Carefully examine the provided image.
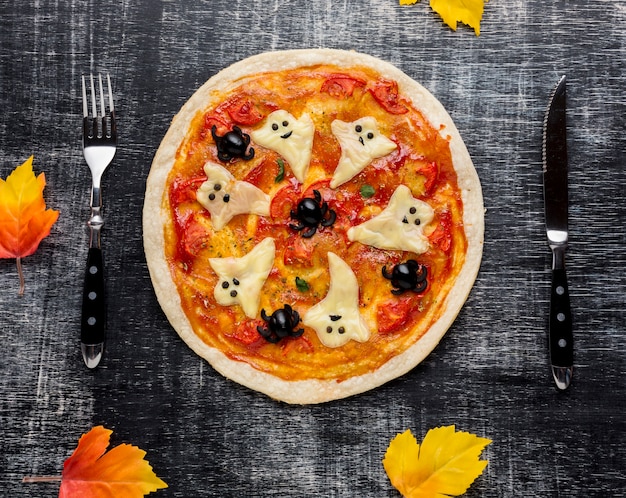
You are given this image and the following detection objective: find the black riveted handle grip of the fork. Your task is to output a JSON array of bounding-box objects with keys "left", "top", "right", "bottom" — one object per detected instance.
[{"left": 80, "top": 247, "right": 106, "bottom": 344}]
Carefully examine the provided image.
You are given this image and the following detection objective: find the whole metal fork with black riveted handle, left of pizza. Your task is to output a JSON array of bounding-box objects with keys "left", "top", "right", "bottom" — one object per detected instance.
[{"left": 80, "top": 74, "right": 117, "bottom": 368}]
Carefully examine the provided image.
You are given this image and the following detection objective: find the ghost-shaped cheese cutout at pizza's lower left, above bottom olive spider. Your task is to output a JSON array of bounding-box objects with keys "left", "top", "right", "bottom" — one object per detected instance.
[{"left": 209, "top": 237, "right": 276, "bottom": 318}]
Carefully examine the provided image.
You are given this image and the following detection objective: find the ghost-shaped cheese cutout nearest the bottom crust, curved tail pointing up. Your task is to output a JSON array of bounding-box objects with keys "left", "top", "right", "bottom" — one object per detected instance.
[{"left": 302, "top": 252, "right": 370, "bottom": 348}]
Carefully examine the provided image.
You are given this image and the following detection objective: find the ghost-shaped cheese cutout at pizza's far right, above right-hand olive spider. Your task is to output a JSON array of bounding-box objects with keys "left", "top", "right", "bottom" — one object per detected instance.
[{"left": 348, "top": 185, "right": 434, "bottom": 254}]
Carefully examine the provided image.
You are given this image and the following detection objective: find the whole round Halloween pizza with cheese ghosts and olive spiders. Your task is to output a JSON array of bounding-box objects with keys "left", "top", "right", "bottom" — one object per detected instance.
[{"left": 143, "top": 49, "right": 483, "bottom": 404}]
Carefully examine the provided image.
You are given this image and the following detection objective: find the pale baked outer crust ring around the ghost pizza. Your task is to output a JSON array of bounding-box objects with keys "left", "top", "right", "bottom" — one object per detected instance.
[{"left": 143, "top": 49, "right": 484, "bottom": 404}]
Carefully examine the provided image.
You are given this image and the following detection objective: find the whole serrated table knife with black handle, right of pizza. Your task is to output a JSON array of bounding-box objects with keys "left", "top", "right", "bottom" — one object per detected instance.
[{"left": 543, "top": 76, "right": 574, "bottom": 390}]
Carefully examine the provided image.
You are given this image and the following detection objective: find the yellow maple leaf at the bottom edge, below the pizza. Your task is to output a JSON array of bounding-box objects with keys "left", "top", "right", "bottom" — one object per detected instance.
[{"left": 383, "top": 425, "right": 491, "bottom": 498}]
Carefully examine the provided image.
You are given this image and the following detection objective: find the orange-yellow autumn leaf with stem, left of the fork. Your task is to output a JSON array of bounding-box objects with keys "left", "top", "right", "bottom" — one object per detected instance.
[{"left": 0, "top": 156, "right": 59, "bottom": 294}]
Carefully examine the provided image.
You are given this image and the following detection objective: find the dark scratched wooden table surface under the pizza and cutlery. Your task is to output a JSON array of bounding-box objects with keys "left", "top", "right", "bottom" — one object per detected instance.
[{"left": 0, "top": 0, "right": 626, "bottom": 498}]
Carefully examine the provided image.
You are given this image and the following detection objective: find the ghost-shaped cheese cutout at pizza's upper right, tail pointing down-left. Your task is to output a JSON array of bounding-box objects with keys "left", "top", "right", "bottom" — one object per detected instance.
[{"left": 330, "top": 116, "right": 397, "bottom": 188}]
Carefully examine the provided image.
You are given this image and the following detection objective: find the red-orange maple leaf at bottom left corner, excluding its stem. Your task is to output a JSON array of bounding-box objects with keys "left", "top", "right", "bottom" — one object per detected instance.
[{"left": 59, "top": 426, "right": 167, "bottom": 498}]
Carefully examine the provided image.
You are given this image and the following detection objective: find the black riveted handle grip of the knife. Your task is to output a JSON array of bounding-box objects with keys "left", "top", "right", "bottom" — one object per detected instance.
[{"left": 549, "top": 268, "right": 574, "bottom": 367}]
